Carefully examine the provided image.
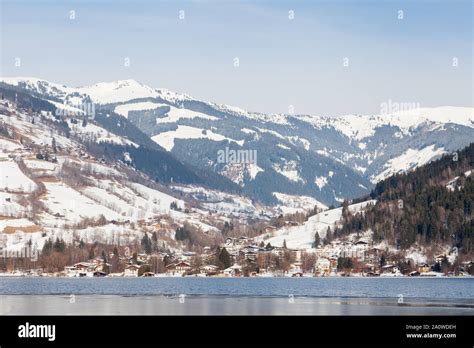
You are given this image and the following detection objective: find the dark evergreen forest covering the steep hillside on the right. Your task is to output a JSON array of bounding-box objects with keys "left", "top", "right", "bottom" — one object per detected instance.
[{"left": 333, "top": 143, "right": 474, "bottom": 254}]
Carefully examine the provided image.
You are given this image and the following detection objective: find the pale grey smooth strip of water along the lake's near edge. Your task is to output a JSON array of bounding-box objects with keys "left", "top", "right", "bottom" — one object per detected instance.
[{"left": 0, "top": 295, "right": 474, "bottom": 315}]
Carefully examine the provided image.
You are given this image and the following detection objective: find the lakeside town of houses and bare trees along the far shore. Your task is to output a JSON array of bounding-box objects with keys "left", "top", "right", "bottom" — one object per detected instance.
[{"left": 0, "top": 235, "right": 474, "bottom": 277}]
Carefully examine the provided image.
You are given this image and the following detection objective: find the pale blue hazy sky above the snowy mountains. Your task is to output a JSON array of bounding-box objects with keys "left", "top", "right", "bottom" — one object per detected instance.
[{"left": 0, "top": 0, "right": 474, "bottom": 116}]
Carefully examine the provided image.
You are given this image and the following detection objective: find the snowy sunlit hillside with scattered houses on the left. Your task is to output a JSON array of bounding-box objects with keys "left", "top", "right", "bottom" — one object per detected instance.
[{"left": 0, "top": 100, "right": 278, "bottom": 251}]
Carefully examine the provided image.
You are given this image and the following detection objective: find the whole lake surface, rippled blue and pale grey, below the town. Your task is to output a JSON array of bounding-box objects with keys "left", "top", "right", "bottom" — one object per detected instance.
[{"left": 0, "top": 277, "right": 474, "bottom": 315}]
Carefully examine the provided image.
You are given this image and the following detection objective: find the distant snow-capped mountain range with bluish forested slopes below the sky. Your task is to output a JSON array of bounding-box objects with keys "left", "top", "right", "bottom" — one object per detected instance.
[{"left": 1, "top": 78, "right": 474, "bottom": 205}]
